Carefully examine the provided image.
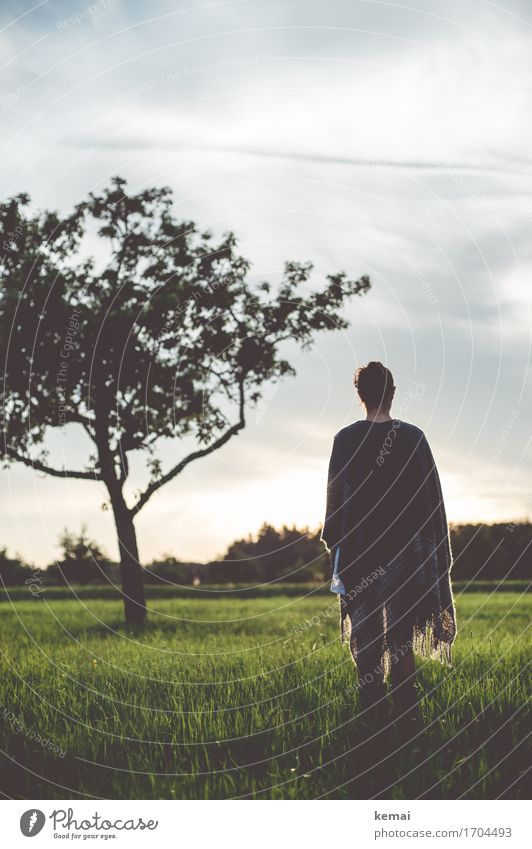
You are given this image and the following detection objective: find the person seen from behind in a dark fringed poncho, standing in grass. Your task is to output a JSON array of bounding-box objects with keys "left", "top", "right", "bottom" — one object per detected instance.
[{"left": 321, "top": 362, "right": 456, "bottom": 723}]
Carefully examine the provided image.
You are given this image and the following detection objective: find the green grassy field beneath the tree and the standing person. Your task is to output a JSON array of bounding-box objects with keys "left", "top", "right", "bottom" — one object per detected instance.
[{"left": 0, "top": 586, "right": 532, "bottom": 799}]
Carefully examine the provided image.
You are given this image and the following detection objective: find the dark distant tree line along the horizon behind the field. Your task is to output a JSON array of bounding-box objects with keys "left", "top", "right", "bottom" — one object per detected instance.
[{"left": 0, "top": 522, "right": 532, "bottom": 586}]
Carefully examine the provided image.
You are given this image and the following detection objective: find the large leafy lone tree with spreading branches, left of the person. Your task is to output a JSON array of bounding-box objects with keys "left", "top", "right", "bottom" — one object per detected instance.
[{"left": 0, "top": 177, "right": 370, "bottom": 624}]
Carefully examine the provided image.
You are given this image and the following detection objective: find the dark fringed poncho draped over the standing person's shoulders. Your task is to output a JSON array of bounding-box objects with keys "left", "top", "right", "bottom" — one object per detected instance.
[{"left": 322, "top": 419, "right": 456, "bottom": 674}]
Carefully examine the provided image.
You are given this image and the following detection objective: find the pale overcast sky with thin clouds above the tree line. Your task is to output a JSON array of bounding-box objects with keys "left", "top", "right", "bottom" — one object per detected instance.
[{"left": 0, "top": 0, "right": 532, "bottom": 565}]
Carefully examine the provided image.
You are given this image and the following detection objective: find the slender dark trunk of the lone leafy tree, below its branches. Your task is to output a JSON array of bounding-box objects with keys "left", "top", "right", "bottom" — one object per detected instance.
[{"left": 113, "top": 498, "right": 146, "bottom": 625}]
